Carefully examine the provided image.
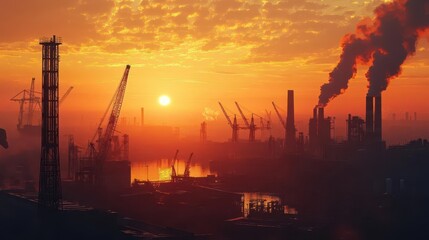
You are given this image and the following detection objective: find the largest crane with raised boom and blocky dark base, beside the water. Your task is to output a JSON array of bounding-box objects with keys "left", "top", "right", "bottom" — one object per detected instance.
[{"left": 73, "top": 65, "right": 131, "bottom": 190}]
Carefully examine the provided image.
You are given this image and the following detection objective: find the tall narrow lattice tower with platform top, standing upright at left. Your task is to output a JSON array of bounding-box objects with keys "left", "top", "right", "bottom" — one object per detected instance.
[{"left": 38, "top": 35, "right": 62, "bottom": 210}]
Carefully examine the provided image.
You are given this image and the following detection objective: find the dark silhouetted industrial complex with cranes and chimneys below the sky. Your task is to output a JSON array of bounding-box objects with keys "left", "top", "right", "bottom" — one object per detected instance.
[{"left": 0, "top": 31, "right": 429, "bottom": 239}]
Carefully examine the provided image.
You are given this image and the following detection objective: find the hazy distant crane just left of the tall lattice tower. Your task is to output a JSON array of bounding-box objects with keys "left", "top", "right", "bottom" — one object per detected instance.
[{"left": 10, "top": 78, "right": 41, "bottom": 135}]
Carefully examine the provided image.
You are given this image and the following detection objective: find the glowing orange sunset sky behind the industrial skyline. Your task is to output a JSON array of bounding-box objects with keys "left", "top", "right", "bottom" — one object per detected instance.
[{"left": 0, "top": 0, "right": 429, "bottom": 142}]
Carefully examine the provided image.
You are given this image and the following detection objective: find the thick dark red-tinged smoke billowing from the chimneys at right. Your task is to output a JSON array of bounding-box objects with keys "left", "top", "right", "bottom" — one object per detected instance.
[{"left": 319, "top": 0, "right": 429, "bottom": 106}]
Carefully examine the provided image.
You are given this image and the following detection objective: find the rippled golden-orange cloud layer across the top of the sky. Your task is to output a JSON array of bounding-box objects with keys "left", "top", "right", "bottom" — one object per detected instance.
[{"left": 0, "top": 0, "right": 392, "bottom": 62}]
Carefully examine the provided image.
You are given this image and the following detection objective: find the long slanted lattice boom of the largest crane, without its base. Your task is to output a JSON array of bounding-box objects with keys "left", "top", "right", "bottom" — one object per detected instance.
[{"left": 95, "top": 65, "right": 130, "bottom": 182}]
